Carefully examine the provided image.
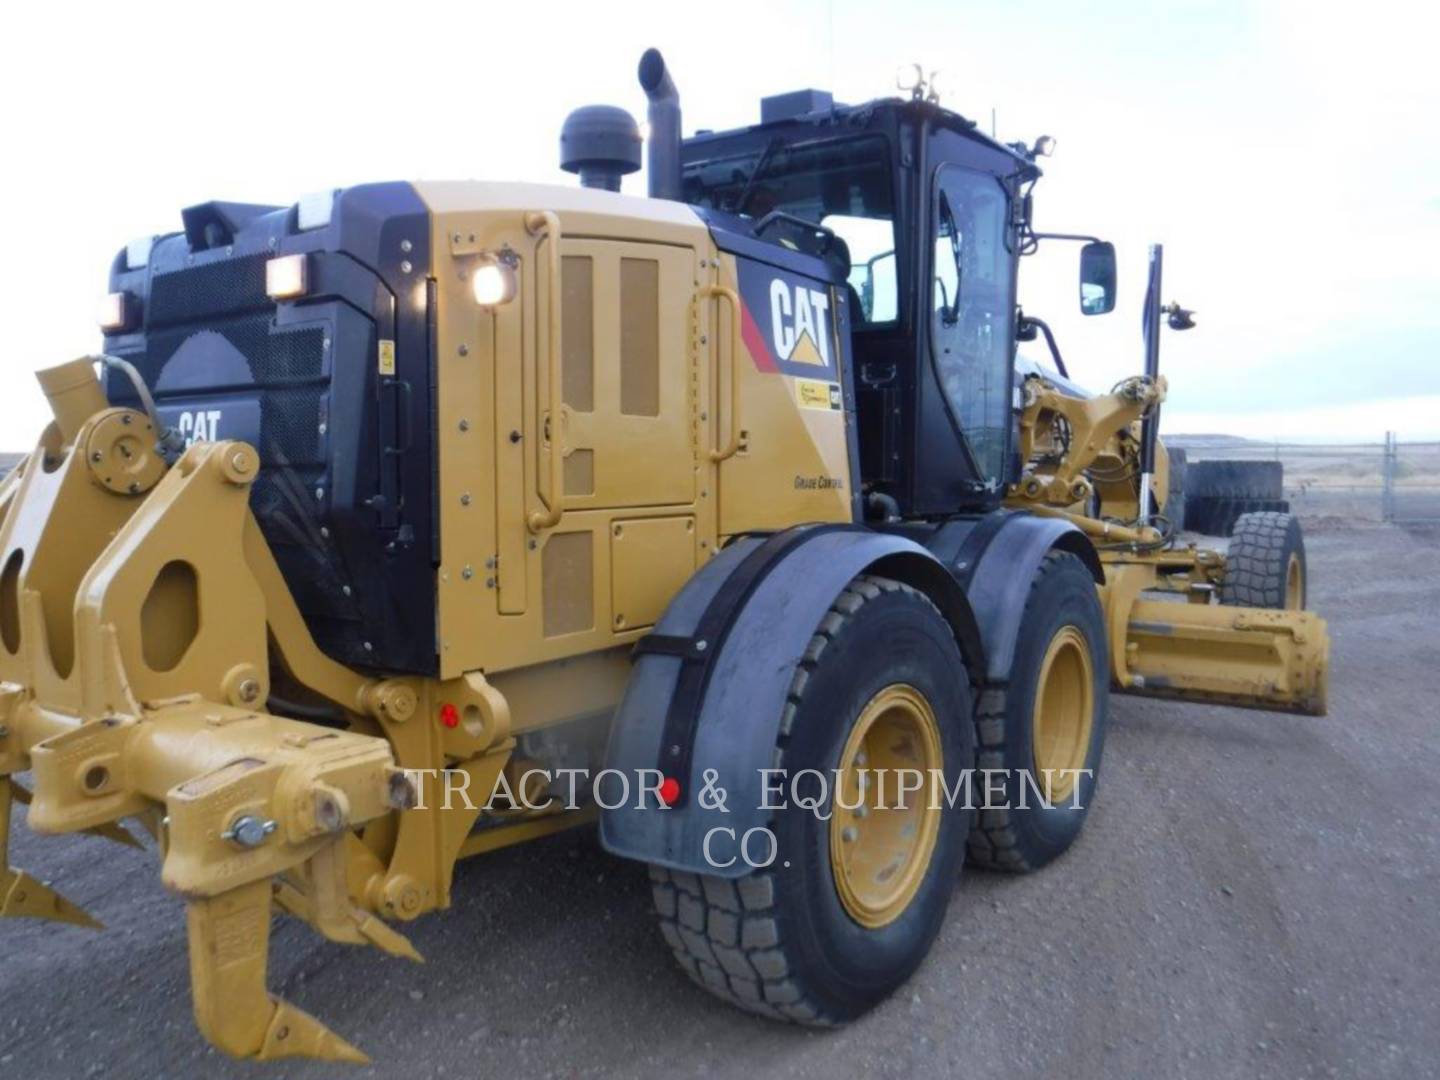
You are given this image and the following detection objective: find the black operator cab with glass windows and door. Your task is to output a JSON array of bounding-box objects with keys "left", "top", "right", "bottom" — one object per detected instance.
[{"left": 680, "top": 89, "right": 1113, "bottom": 518}]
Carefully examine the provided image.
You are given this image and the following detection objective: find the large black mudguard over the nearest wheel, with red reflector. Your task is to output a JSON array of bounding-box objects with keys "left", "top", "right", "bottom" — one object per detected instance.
[{"left": 600, "top": 526, "right": 984, "bottom": 877}]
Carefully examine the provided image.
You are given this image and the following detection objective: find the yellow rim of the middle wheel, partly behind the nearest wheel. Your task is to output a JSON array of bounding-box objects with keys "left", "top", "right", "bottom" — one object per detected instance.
[{"left": 1031, "top": 626, "right": 1094, "bottom": 802}]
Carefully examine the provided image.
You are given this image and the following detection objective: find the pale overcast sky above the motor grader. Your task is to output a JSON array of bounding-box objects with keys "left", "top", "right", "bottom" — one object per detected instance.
[{"left": 0, "top": 0, "right": 1440, "bottom": 449}]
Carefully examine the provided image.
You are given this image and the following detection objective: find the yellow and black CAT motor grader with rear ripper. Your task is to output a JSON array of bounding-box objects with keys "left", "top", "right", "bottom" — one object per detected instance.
[{"left": 0, "top": 50, "right": 1328, "bottom": 1061}]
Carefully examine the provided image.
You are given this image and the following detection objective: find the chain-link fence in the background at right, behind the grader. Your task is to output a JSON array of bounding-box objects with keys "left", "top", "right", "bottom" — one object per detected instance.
[{"left": 1165, "top": 433, "right": 1440, "bottom": 524}]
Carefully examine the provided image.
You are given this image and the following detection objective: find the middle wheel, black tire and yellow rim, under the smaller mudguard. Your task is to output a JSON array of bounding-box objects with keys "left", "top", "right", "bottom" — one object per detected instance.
[{"left": 969, "top": 552, "right": 1110, "bottom": 873}]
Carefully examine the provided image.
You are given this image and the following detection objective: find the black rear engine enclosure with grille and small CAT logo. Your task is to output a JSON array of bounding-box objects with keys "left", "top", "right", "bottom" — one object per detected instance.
[{"left": 105, "top": 183, "right": 438, "bottom": 674}]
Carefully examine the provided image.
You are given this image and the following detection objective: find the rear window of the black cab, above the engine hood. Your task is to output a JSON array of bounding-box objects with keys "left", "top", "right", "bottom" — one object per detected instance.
[{"left": 684, "top": 135, "right": 897, "bottom": 327}]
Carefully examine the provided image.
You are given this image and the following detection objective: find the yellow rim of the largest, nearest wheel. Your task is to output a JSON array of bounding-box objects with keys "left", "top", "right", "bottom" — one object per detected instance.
[{"left": 829, "top": 683, "right": 945, "bottom": 929}]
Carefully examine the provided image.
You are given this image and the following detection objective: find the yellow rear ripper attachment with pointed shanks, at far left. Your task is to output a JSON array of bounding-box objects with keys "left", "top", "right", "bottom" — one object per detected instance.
[{"left": 0, "top": 360, "right": 419, "bottom": 1061}]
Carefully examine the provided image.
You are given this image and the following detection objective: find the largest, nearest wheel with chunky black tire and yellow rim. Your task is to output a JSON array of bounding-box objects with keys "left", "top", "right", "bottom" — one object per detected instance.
[{"left": 651, "top": 576, "right": 973, "bottom": 1025}]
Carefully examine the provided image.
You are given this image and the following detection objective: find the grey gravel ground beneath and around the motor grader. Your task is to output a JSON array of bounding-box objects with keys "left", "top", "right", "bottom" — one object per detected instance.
[{"left": 0, "top": 526, "right": 1440, "bottom": 1080}]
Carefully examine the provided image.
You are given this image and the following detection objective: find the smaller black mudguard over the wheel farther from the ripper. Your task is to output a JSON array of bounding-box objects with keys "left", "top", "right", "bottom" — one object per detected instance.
[{"left": 926, "top": 510, "right": 1104, "bottom": 684}]
